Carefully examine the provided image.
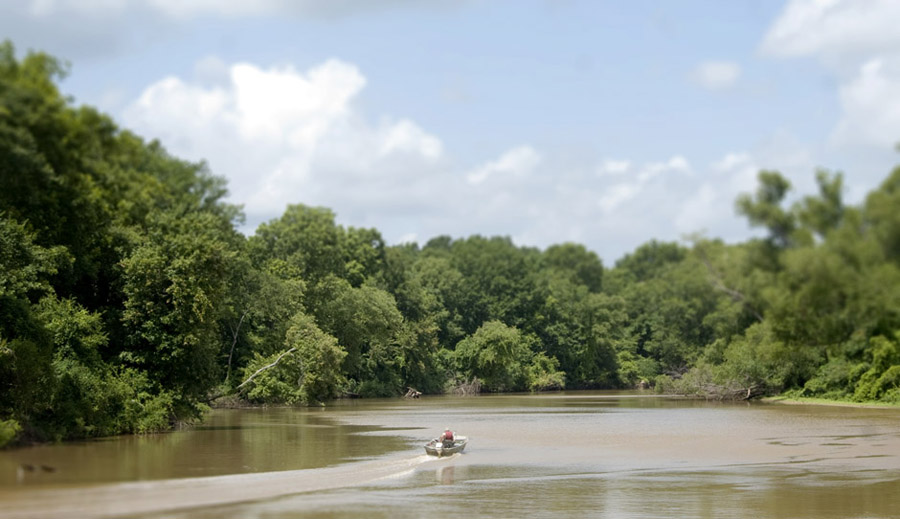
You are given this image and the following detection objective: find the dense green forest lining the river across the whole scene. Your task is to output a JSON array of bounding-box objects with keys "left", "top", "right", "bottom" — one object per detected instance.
[{"left": 0, "top": 42, "right": 900, "bottom": 446}]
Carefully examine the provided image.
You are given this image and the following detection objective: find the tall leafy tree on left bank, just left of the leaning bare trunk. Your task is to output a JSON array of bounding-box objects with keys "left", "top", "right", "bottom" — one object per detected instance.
[{"left": 121, "top": 212, "right": 239, "bottom": 416}]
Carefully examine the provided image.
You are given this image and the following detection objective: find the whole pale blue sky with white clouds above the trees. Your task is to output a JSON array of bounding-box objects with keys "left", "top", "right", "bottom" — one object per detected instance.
[{"left": 0, "top": 0, "right": 900, "bottom": 260}]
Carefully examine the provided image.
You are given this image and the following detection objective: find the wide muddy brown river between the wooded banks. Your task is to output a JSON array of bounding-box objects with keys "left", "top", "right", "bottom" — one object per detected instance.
[{"left": 0, "top": 392, "right": 900, "bottom": 519}]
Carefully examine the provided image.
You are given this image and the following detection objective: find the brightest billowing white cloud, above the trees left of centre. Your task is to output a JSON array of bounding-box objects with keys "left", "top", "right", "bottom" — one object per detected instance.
[{"left": 124, "top": 60, "right": 443, "bottom": 225}]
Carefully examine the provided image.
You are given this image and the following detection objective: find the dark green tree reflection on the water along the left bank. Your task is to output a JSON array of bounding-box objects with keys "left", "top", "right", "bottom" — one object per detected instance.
[{"left": 0, "top": 408, "right": 406, "bottom": 488}]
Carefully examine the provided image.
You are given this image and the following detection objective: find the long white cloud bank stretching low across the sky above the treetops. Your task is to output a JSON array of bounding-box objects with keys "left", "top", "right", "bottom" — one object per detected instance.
[{"left": 123, "top": 54, "right": 811, "bottom": 261}]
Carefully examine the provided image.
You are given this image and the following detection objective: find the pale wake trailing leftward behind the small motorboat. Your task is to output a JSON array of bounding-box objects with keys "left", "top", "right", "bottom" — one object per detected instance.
[{"left": 0, "top": 454, "right": 436, "bottom": 519}]
